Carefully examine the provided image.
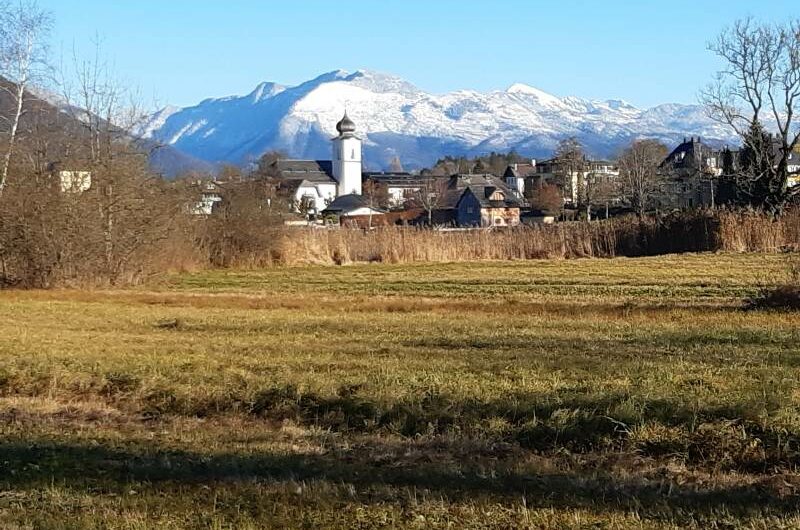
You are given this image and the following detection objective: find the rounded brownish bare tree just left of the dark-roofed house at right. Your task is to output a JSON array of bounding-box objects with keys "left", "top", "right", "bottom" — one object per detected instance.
[{"left": 619, "top": 140, "right": 669, "bottom": 218}]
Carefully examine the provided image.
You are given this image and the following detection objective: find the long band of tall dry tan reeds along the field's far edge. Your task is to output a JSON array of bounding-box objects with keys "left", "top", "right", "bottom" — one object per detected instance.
[{"left": 242, "top": 211, "right": 800, "bottom": 266}]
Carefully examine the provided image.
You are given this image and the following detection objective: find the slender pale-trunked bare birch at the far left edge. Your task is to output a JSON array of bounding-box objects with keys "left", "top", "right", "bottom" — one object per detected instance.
[{"left": 0, "top": 0, "right": 52, "bottom": 194}]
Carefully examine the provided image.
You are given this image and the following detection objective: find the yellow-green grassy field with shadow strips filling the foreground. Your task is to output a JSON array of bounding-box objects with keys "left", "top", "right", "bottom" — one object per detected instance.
[{"left": 0, "top": 254, "right": 800, "bottom": 529}]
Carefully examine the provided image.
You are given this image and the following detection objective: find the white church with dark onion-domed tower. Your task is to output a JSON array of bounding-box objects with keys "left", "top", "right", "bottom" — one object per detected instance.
[{"left": 275, "top": 111, "right": 383, "bottom": 216}]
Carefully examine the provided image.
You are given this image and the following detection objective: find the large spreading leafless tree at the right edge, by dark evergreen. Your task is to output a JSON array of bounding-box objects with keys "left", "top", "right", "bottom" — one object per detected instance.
[{"left": 701, "top": 19, "right": 800, "bottom": 215}]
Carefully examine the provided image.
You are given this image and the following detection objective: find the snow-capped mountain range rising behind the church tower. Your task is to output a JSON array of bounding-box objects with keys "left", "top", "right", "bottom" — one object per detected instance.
[{"left": 137, "top": 70, "right": 735, "bottom": 169}]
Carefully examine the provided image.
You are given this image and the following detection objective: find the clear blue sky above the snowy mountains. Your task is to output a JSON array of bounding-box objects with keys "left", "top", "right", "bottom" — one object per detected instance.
[{"left": 40, "top": 0, "right": 800, "bottom": 106}]
